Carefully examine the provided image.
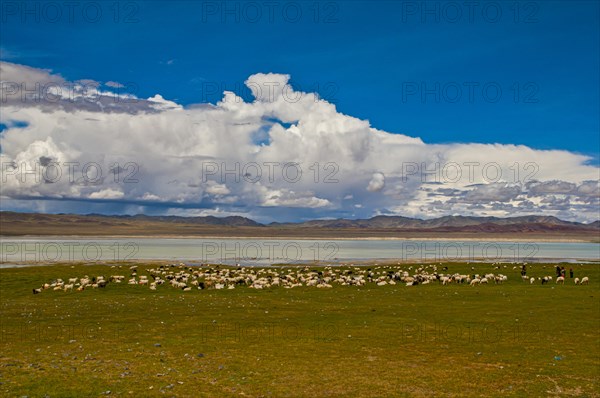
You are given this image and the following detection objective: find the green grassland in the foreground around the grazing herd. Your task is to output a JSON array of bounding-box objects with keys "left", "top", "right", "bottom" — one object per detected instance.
[{"left": 0, "top": 264, "right": 600, "bottom": 397}]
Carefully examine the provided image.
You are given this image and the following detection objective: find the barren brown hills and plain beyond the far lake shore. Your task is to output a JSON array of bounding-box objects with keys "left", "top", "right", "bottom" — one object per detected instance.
[{"left": 0, "top": 212, "right": 600, "bottom": 242}]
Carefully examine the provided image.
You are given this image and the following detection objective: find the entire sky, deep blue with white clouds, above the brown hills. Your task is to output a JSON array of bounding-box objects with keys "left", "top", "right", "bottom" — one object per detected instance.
[{"left": 0, "top": 0, "right": 600, "bottom": 222}]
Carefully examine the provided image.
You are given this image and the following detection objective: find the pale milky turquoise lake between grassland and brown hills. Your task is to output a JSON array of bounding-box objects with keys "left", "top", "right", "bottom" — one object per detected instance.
[{"left": 0, "top": 237, "right": 600, "bottom": 268}]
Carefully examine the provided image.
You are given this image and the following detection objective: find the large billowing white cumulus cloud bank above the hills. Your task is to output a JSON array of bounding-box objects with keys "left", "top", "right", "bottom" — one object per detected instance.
[{"left": 0, "top": 62, "right": 600, "bottom": 221}]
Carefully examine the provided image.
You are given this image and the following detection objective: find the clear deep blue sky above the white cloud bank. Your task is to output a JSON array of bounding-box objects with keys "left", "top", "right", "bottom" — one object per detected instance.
[{"left": 1, "top": 1, "right": 600, "bottom": 161}]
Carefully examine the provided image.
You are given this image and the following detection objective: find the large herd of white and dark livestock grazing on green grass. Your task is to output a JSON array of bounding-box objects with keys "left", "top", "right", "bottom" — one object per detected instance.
[{"left": 33, "top": 263, "right": 589, "bottom": 294}]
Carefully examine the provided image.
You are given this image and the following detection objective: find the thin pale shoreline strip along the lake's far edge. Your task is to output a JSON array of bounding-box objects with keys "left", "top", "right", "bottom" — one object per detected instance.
[{"left": 0, "top": 235, "right": 600, "bottom": 244}]
